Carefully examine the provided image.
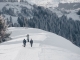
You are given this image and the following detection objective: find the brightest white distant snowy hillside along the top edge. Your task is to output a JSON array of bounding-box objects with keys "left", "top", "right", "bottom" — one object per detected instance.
[{"left": 26, "top": 0, "right": 80, "bottom": 7}]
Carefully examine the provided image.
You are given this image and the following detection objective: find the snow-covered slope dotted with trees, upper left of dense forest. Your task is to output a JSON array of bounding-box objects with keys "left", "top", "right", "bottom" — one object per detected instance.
[{"left": 0, "top": 2, "right": 32, "bottom": 24}]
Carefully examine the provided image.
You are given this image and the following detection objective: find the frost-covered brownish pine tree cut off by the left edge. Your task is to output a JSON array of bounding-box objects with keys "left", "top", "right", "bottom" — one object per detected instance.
[{"left": 0, "top": 16, "right": 11, "bottom": 42}]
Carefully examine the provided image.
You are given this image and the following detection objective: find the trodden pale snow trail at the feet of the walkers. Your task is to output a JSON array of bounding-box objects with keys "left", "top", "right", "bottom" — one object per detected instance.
[{"left": 14, "top": 43, "right": 41, "bottom": 60}]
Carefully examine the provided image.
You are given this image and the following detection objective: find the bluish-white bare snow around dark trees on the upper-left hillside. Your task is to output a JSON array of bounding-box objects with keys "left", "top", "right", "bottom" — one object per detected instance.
[{"left": 0, "top": 2, "right": 32, "bottom": 24}]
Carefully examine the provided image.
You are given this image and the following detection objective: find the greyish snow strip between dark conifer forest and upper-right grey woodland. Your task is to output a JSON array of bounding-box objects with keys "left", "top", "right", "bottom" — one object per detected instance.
[{"left": 49, "top": 8, "right": 80, "bottom": 21}]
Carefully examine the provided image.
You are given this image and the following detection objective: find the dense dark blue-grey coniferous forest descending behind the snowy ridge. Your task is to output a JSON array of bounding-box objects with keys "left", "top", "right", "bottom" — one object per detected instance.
[{"left": 18, "top": 5, "right": 80, "bottom": 47}]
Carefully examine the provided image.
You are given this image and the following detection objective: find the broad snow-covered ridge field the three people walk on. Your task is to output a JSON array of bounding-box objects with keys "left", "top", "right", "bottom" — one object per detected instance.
[{"left": 0, "top": 27, "right": 80, "bottom": 60}]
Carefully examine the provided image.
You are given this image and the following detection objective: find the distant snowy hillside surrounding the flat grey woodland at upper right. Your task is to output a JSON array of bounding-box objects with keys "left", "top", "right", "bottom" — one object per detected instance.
[{"left": 26, "top": 0, "right": 80, "bottom": 21}]
